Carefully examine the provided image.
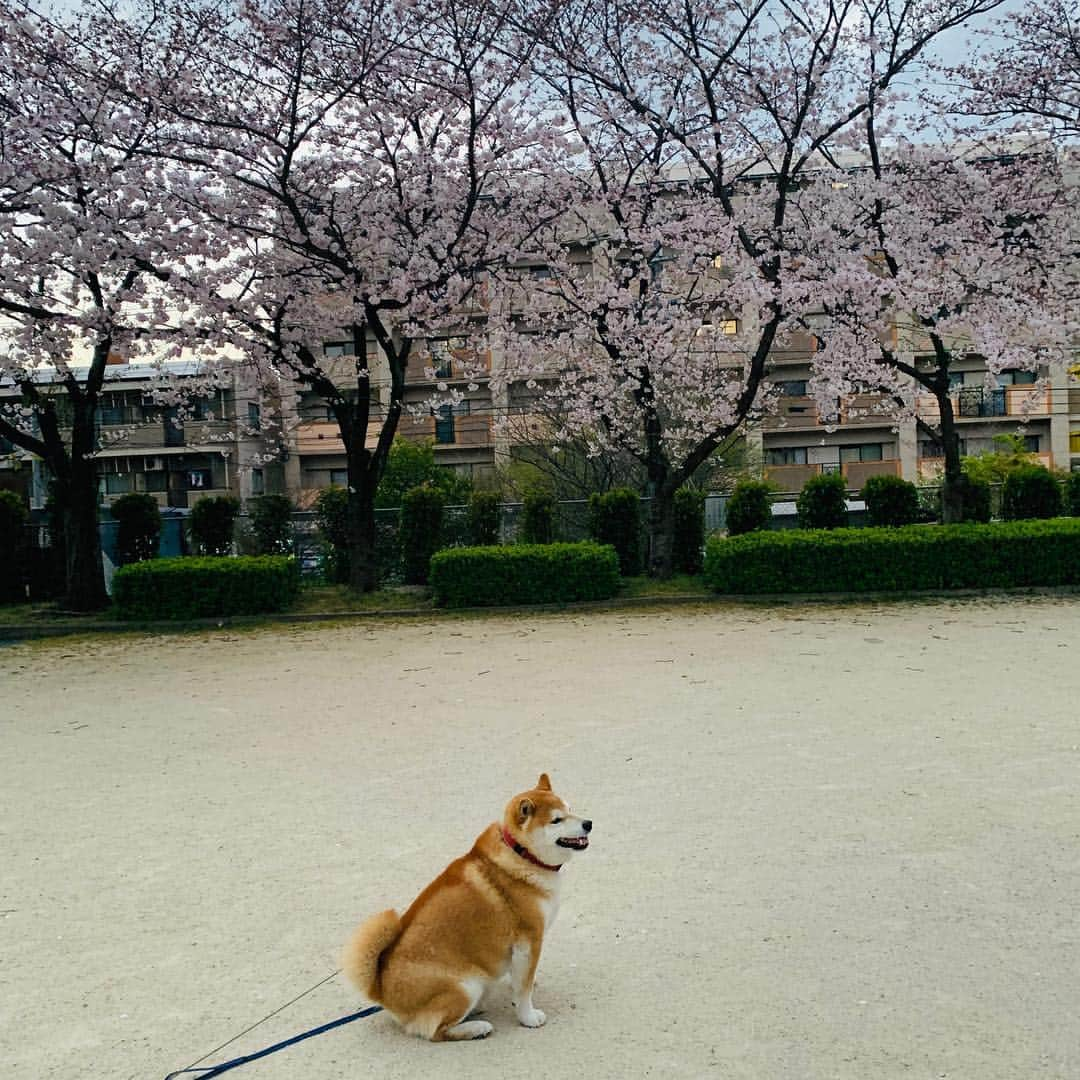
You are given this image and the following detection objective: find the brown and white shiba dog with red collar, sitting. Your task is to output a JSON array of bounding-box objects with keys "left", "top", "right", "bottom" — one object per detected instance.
[{"left": 342, "top": 773, "right": 593, "bottom": 1042}]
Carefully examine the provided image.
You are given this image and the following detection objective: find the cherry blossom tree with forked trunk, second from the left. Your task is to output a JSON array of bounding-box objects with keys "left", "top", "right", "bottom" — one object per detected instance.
[{"left": 133, "top": 0, "right": 546, "bottom": 590}]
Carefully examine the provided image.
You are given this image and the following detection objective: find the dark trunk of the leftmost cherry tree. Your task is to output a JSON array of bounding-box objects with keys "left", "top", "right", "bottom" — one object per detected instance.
[{"left": 54, "top": 400, "right": 109, "bottom": 611}]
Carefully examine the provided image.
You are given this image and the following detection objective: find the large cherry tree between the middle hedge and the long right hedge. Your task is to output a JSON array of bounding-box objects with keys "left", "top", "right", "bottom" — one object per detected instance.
[{"left": 496, "top": 0, "right": 1000, "bottom": 576}]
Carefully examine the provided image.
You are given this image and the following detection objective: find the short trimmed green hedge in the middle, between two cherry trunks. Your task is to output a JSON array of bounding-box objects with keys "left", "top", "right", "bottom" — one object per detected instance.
[{"left": 429, "top": 543, "right": 619, "bottom": 607}]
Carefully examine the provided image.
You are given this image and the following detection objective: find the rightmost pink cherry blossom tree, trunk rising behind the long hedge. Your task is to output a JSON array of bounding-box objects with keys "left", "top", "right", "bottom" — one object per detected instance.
[{"left": 811, "top": 141, "right": 1080, "bottom": 522}]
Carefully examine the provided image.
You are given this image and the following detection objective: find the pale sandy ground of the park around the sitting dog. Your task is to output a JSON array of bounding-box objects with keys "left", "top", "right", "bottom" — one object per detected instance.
[{"left": 0, "top": 599, "right": 1080, "bottom": 1080}]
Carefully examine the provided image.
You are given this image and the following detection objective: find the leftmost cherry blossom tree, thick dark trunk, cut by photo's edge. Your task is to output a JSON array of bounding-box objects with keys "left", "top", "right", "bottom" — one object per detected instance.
[{"left": 0, "top": 0, "right": 220, "bottom": 610}]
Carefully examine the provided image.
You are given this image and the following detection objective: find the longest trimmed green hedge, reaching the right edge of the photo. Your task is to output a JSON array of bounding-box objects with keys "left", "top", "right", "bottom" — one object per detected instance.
[{"left": 704, "top": 517, "right": 1080, "bottom": 594}]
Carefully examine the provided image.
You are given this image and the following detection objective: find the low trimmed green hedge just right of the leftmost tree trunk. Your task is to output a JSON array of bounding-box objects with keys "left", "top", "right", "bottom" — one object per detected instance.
[{"left": 112, "top": 555, "right": 300, "bottom": 619}]
